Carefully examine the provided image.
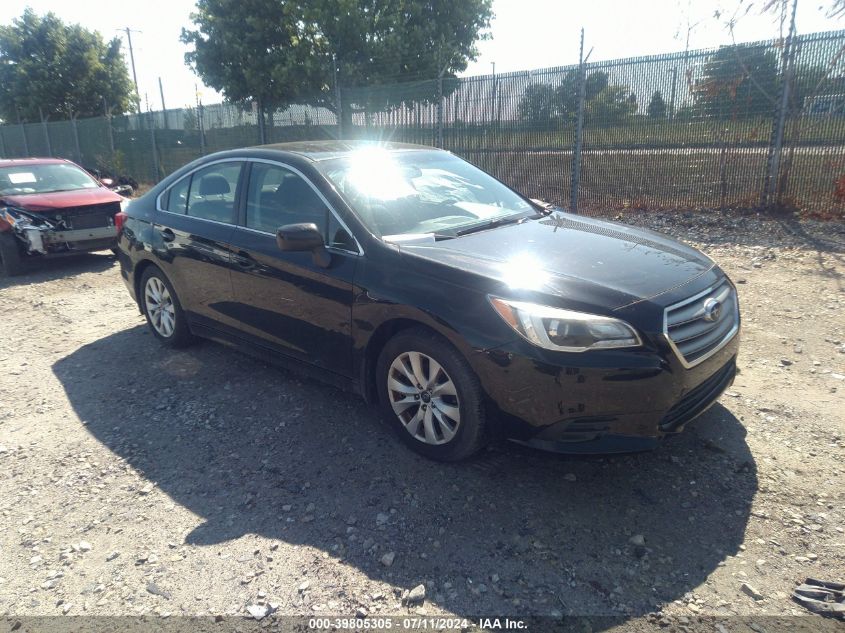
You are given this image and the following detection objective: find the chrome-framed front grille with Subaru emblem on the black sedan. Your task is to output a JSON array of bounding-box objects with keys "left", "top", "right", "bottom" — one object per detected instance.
[{"left": 663, "top": 279, "right": 739, "bottom": 367}]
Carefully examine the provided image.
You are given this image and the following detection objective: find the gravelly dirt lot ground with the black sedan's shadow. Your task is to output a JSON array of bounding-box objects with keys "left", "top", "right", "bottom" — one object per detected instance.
[{"left": 0, "top": 215, "right": 845, "bottom": 631}]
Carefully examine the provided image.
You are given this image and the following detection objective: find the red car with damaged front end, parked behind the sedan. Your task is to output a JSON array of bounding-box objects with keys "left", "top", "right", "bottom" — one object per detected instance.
[{"left": 0, "top": 158, "right": 127, "bottom": 275}]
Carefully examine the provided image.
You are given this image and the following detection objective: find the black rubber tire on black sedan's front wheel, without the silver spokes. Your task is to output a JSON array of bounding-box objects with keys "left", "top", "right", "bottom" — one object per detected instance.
[{"left": 375, "top": 328, "right": 490, "bottom": 462}]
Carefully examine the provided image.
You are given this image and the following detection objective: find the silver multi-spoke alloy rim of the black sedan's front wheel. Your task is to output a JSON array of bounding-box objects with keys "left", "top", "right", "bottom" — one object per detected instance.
[{"left": 387, "top": 352, "right": 461, "bottom": 445}]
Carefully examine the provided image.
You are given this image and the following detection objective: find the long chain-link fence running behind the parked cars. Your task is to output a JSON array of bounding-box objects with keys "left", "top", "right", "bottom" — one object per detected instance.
[{"left": 0, "top": 31, "right": 845, "bottom": 215}]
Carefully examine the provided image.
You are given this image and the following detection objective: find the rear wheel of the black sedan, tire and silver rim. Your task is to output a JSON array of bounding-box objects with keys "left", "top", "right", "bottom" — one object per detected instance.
[{"left": 139, "top": 266, "right": 196, "bottom": 348}]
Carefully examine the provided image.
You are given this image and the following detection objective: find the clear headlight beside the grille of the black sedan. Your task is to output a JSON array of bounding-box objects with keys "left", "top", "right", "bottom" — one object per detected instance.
[{"left": 489, "top": 297, "right": 642, "bottom": 352}]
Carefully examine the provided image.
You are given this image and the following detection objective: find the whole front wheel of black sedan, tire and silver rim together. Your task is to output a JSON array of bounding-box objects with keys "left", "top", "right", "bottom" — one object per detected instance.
[{"left": 376, "top": 329, "right": 490, "bottom": 462}]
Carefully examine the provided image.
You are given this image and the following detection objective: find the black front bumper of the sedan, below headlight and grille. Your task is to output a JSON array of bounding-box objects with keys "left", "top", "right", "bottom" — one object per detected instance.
[{"left": 471, "top": 333, "right": 739, "bottom": 453}]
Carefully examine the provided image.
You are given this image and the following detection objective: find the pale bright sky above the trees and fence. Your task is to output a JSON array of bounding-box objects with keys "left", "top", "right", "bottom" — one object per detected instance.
[{"left": 0, "top": 0, "right": 845, "bottom": 110}]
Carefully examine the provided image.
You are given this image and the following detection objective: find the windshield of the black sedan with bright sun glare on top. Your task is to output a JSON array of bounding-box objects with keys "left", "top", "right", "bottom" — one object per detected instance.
[{"left": 320, "top": 148, "right": 534, "bottom": 241}]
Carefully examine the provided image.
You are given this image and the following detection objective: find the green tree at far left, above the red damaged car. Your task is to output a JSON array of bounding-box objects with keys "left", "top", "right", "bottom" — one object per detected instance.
[{"left": 0, "top": 9, "right": 133, "bottom": 122}]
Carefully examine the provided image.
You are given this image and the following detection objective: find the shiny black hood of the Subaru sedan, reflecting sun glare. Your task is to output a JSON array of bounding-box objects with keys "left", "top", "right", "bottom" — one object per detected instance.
[{"left": 400, "top": 213, "right": 718, "bottom": 309}]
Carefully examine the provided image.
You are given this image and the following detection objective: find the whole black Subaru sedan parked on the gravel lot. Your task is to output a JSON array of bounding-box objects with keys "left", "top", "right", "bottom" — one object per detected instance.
[{"left": 113, "top": 141, "right": 740, "bottom": 460}]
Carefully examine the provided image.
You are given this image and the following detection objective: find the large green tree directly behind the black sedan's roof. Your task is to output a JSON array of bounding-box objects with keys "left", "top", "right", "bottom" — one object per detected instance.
[{"left": 182, "top": 0, "right": 492, "bottom": 122}]
